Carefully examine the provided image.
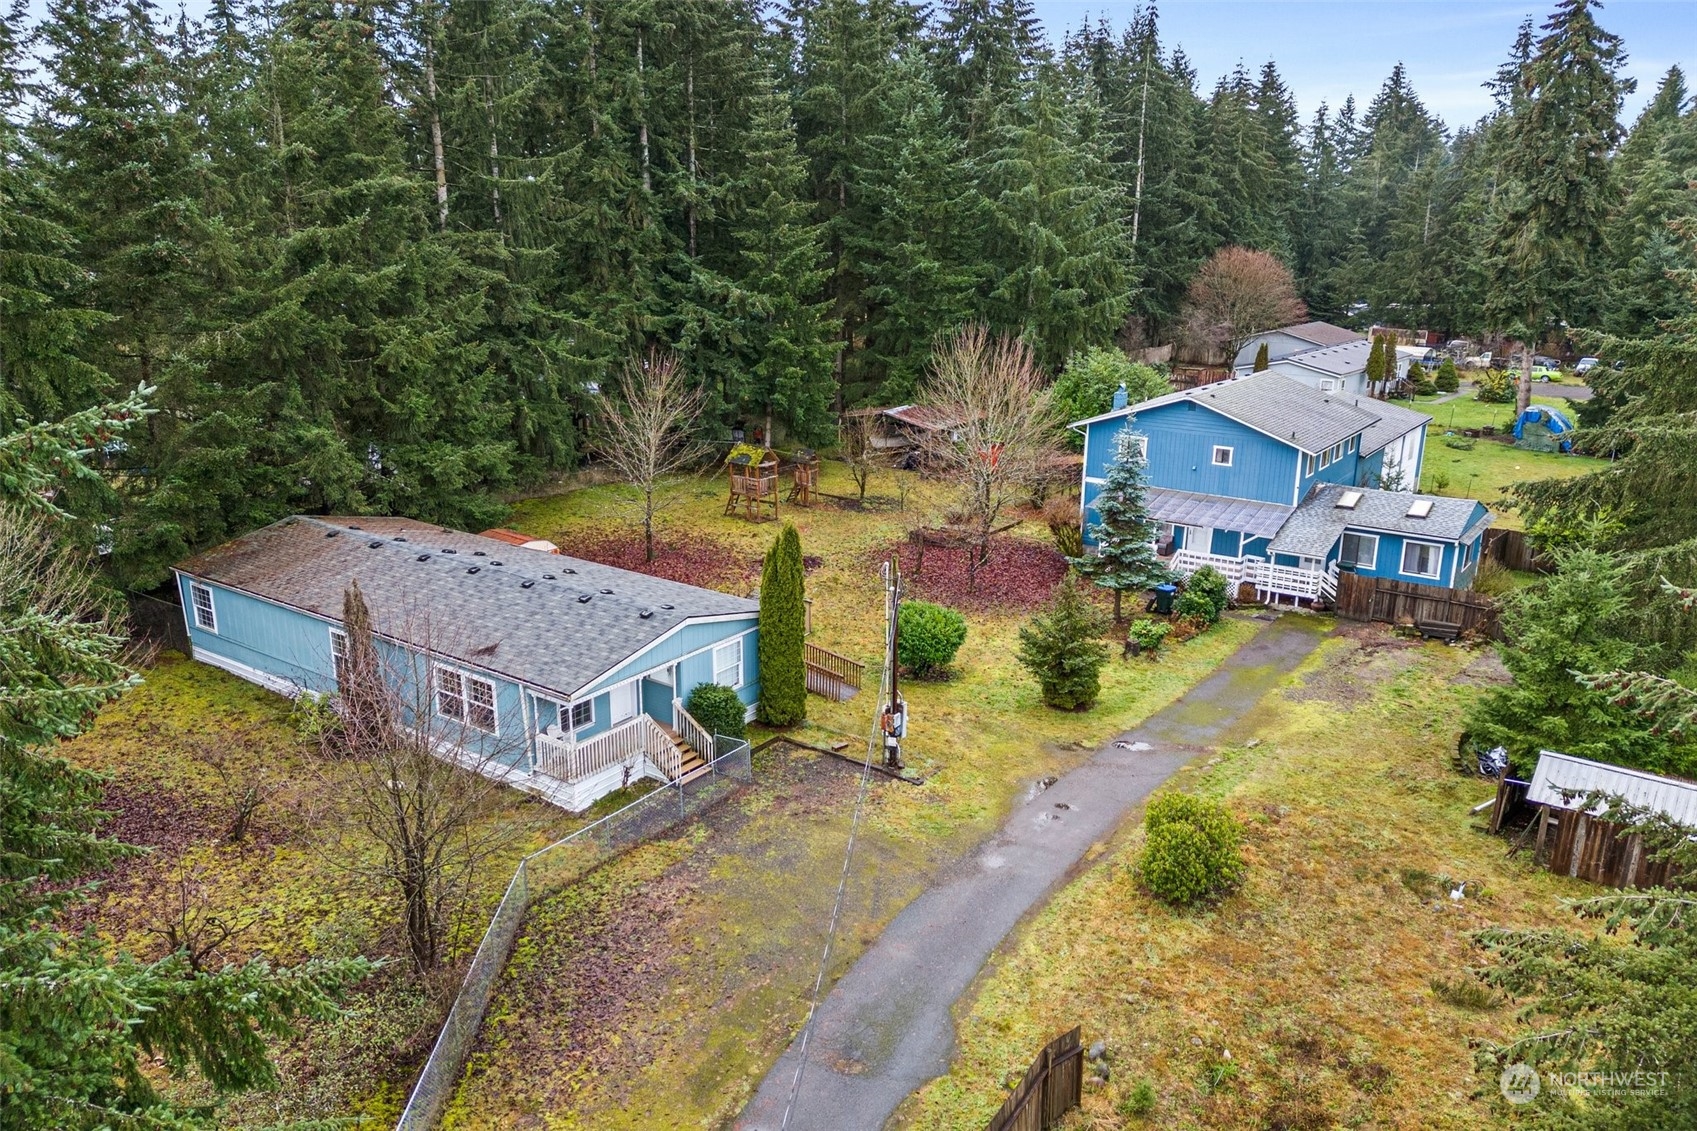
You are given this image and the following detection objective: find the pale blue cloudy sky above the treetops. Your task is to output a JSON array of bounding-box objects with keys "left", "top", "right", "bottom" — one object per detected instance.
[{"left": 1032, "top": 0, "right": 1697, "bottom": 127}]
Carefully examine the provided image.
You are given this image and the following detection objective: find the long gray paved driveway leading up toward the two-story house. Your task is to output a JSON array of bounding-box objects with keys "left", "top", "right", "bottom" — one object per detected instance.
[{"left": 736, "top": 615, "right": 1322, "bottom": 1131}]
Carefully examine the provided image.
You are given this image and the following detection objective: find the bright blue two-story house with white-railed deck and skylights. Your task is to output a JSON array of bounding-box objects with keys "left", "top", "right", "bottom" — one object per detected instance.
[{"left": 1073, "top": 372, "right": 1490, "bottom": 598}]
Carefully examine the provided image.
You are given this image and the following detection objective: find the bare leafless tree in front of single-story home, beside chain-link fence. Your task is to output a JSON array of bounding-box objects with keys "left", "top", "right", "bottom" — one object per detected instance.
[{"left": 326, "top": 584, "right": 512, "bottom": 971}]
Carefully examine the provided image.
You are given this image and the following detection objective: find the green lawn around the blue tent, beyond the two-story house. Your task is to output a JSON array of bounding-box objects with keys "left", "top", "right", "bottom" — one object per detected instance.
[{"left": 1414, "top": 394, "right": 1609, "bottom": 530}]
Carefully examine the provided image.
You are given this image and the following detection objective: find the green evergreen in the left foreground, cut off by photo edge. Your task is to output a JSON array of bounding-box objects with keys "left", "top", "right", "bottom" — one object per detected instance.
[{"left": 0, "top": 399, "right": 372, "bottom": 1129}]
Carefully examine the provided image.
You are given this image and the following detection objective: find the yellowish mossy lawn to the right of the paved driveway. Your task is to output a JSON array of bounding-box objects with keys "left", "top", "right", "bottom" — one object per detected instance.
[{"left": 894, "top": 627, "right": 1583, "bottom": 1131}]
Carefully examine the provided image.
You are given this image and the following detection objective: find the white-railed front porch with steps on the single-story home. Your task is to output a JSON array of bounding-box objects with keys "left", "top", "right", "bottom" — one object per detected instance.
[{"left": 529, "top": 700, "right": 718, "bottom": 812}]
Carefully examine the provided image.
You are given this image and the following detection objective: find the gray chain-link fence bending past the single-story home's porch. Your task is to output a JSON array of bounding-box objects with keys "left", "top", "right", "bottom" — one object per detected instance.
[{"left": 395, "top": 735, "right": 753, "bottom": 1131}]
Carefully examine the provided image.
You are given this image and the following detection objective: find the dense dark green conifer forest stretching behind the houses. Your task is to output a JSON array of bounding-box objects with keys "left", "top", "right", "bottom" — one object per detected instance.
[{"left": 0, "top": 0, "right": 1697, "bottom": 584}]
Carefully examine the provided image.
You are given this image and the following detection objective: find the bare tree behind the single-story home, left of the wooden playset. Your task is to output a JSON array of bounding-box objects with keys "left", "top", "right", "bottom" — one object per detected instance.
[{"left": 592, "top": 350, "right": 708, "bottom": 562}]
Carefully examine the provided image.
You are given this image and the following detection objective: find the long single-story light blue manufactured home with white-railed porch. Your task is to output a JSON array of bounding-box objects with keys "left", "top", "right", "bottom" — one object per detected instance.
[{"left": 176, "top": 516, "right": 760, "bottom": 810}]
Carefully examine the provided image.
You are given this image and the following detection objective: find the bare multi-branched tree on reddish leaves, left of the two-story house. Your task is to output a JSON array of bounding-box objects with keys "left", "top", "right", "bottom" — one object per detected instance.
[{"left": 920, "top": 326, "right": 1057, "bottom": 576}]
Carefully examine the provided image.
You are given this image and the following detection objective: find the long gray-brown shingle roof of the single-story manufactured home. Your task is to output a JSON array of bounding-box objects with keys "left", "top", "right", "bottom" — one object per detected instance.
[{"left": 178, "top": 516, "right": 760, "bottom": 695}]
